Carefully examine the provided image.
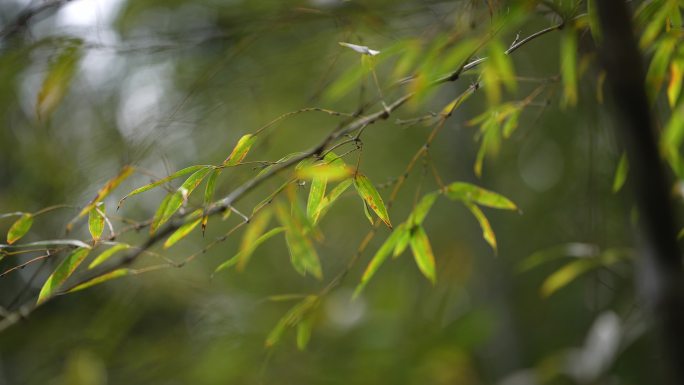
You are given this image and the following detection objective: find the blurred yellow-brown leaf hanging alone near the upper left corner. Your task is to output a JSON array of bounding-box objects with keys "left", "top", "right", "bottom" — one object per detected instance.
[{"left": 36, "top": 41, "right": 82, "bottom": 119}]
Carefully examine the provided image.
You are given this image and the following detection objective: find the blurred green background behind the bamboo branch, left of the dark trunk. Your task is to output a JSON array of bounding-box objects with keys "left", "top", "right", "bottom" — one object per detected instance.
[{"left": 0, "top": 0, "right": 658, "bottom": 385}]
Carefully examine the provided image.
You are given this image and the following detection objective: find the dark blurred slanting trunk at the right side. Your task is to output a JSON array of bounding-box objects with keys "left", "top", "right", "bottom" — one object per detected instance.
[{"left": 596, "top": 0, "right": 684, "bottom": 384}]
